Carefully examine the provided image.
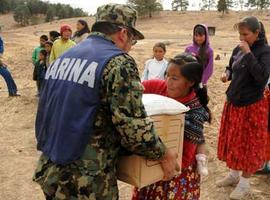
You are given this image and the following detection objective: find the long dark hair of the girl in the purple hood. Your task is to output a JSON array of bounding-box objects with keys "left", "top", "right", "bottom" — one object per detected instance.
[{"left": 194, "top": 25, "right": 207, "bottom": 68}]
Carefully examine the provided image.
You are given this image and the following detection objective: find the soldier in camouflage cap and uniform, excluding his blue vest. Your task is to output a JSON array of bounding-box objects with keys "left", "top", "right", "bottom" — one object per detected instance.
[{"left": 33, "top": 4, "right": 177, "bottom": 200}]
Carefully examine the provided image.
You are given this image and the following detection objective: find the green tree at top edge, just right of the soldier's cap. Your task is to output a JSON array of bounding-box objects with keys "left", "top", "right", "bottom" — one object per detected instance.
[{"left": 128, "top": 0, "right": 163, "bottom": 18}]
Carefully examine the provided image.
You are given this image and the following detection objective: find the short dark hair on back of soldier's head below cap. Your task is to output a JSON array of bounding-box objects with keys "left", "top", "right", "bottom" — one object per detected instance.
[{"left": 91, "top": 22, "right": 121, "bottom": 35}]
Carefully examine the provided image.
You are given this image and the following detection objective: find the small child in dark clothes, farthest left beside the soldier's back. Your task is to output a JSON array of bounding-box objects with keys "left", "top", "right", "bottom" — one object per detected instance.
[{"left": 33, "top": 49, "right": 47, "bottom": 96}]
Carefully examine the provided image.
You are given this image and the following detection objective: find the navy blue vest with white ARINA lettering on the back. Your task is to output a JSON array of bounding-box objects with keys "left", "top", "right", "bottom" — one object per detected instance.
[{"left": 36, "top": 36, "right": 124, "bottom": 164}]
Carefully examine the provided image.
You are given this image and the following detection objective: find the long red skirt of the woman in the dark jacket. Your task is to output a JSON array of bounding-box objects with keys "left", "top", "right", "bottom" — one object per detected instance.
[{"left": 218, "top": 98, "right": 269, "bottom": 173}]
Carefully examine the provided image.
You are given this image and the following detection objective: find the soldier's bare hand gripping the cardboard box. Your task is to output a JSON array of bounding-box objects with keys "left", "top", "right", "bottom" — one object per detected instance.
[{"left": 161, "top": 149, "right": 180, "bottom": 180}]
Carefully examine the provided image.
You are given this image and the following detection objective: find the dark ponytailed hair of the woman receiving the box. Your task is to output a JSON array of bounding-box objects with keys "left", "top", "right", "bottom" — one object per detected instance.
[{"left": 169, "top": 53, "right": 212, "bottom": 123}]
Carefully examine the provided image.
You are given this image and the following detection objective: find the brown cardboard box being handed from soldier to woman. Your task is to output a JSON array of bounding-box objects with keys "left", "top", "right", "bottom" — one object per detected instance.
[{"left": 117, "top": 114, "right": 184, "bottom": 188}]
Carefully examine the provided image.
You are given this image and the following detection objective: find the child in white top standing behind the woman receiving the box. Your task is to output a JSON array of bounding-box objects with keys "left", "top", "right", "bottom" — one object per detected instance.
[{"left": 142, "top": 42, "right": 168, "bottom": 81}]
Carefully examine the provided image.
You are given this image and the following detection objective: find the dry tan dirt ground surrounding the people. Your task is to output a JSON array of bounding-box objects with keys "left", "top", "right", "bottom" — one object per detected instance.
[{"left": 0, "top": 12, "right": 270, "bottom": 200}]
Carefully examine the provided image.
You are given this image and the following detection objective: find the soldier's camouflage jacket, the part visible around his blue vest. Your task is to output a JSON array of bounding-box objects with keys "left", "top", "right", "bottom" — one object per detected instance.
[{"left": 34, "top": 33, "right": 165, "bottom": 200}]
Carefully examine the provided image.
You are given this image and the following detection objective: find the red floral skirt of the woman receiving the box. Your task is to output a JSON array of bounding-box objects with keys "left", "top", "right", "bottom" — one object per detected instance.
[{"left": 132, "top": 165, "right": 200, "bottom": 200}]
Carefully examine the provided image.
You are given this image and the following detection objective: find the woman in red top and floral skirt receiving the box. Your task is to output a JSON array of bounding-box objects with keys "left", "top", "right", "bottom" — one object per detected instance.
[{"left": 133, "top": 54, "right": 211, "bottom": 200}]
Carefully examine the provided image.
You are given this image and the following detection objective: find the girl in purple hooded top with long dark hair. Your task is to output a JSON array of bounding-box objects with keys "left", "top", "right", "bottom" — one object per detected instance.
[{"left": 185, "top": 24, "right": 214, "bottom": 85}]
